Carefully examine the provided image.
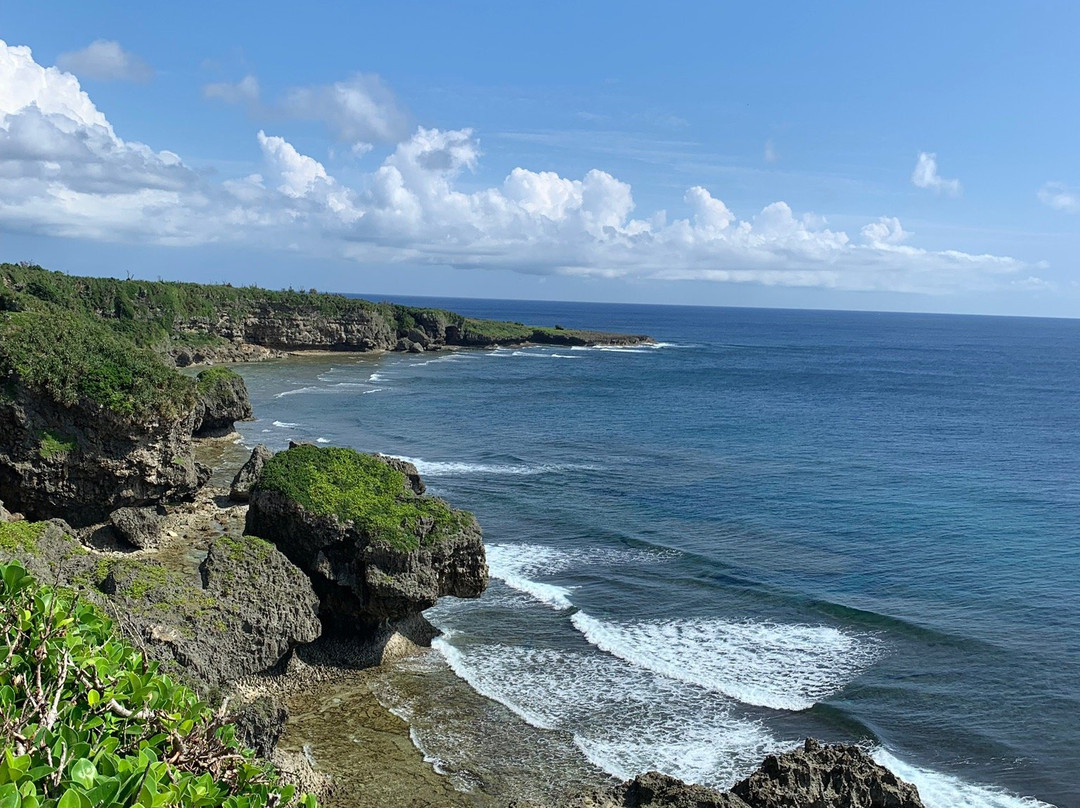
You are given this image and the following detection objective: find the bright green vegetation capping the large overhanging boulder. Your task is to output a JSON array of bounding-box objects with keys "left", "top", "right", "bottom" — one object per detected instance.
[{"left": 255, "top": 444, "right": 469, "bottom": 550}]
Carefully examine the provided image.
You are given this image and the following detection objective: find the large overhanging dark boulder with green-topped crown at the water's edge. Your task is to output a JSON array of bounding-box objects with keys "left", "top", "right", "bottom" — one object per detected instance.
[{"left": 246, "top": 445, "right": 487, "bottom": 635}]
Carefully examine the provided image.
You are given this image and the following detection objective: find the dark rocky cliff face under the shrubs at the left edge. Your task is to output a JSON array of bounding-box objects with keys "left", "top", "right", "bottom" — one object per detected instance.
[{"left": 0, "top": 385, "right": 210, "bottom": 526}]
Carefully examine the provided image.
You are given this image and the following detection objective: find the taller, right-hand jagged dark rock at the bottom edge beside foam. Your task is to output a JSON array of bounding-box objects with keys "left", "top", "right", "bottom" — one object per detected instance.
[{"left": 731, "top": 738, "right": 923, "bottom": 808}]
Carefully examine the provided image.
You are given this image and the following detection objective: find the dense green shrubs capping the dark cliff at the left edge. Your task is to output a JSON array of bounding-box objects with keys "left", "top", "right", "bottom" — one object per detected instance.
[{"left": 0, "top": 307, "right": 194, "bottom": 418}]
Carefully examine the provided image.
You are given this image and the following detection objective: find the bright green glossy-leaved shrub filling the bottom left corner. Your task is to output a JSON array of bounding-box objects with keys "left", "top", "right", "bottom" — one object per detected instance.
[{"left": 0, "top": 564, "right": 315, "bottom": 808}]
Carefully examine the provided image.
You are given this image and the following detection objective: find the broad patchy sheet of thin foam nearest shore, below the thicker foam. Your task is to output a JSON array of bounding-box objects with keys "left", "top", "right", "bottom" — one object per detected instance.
[{"left": 433, "top": 637, "right": 792, "bottom": 787}]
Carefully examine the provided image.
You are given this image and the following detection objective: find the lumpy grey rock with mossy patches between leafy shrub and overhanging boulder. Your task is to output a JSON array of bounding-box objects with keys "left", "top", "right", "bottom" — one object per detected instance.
[{"left": 92, "top": 536, "right": 322, "bottom": 688}]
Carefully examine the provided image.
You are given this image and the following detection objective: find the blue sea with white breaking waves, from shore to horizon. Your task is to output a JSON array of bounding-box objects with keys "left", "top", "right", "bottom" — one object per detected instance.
[{"left": 232, "top": 298, "right": 1080, "bottom": 808}]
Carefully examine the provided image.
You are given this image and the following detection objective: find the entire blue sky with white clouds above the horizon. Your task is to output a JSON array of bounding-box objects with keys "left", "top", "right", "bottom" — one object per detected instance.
[{"left": 0, "top": 0, "right": 1080, "bottom": 317}]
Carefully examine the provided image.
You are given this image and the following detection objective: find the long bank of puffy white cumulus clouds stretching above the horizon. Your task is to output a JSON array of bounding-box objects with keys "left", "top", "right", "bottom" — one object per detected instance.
[{"left": 0, "top": 42, "right": 1038, "bottom": 292}]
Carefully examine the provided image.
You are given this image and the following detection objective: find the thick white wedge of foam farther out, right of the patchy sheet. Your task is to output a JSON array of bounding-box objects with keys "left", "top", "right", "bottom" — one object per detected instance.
[{"left": 571, "top": 611, "right": 880, "bottom": 710}]
